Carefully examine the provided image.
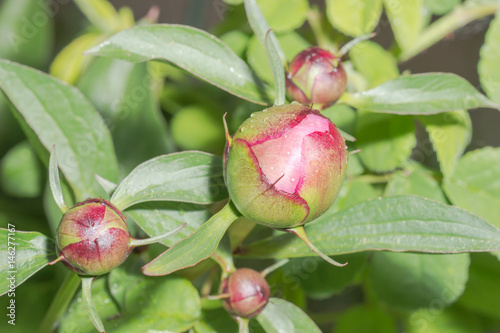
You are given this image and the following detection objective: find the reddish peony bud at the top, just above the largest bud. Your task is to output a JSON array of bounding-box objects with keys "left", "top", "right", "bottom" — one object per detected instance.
[{"left": 286, "top": 47, "right": 346, "bottom": 109}]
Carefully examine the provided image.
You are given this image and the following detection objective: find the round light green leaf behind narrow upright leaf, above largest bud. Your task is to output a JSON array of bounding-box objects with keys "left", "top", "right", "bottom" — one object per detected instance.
[{"left": 246, "top": 32, "right": 310, "bottom": 83}]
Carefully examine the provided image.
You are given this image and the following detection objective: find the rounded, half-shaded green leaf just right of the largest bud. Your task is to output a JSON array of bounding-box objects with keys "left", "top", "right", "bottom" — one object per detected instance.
[{"left": 355, "top": 110, "right": 417, "bottom": 172}]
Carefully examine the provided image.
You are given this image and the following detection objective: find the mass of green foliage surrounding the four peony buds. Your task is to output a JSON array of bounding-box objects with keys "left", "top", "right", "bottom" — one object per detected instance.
[{"left": 0, "top": 0, "right": 500, "bottom": 333}]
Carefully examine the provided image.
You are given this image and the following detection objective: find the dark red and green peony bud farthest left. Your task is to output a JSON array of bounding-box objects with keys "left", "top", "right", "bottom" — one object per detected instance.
[{"left": 57, "top": 199, "right": 132, "bottom": 275}]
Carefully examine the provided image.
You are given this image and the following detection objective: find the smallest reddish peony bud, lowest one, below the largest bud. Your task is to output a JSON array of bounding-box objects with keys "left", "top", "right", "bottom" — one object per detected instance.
[{"left": 222, "top": 268, "right": 269, "bottom": 318}]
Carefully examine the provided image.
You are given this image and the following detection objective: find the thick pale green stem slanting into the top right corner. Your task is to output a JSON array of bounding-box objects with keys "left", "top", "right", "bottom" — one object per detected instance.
[{"left": 399, "top": 4, "right": 500, "bottom": 62}]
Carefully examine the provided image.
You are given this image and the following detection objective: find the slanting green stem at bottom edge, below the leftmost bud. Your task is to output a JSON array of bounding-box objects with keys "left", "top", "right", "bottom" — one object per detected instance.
[{"left": 37, "top": 272, "right": 80, "bottom": 333}]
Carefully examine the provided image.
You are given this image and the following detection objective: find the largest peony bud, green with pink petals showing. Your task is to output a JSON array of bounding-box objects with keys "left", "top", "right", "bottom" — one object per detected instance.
[{"left": 224, "top": 103, "right": 347, "bottom": 228}]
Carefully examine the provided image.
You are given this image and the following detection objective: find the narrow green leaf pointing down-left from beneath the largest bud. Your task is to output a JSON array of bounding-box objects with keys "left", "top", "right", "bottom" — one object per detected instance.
[{"left": 143, "top": 202, "right": 241, "bottom": 275}]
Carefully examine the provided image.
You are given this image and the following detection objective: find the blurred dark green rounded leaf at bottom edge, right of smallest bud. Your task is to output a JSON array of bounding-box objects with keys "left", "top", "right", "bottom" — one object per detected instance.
[{"left": 332, "top": 305, "right": 397, "bottom": 333}]
